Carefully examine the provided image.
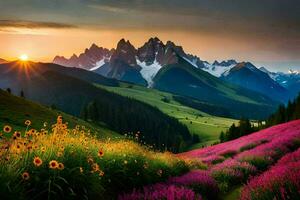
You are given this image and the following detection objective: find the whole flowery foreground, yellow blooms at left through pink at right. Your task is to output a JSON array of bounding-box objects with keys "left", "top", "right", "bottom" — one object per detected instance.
[{"left": 0, "top": 112, "right": 300, "bottom": 200}]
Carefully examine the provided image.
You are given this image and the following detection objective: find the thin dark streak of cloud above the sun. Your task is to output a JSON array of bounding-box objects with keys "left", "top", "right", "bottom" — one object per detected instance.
[{"left": 0, "top": 20, "right": 77, "bottom": 29}]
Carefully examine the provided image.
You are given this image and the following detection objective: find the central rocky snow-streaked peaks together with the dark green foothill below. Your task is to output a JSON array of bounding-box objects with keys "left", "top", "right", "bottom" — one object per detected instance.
[{"left": 52, "top": 37, "right": 277, "bottom": 118}]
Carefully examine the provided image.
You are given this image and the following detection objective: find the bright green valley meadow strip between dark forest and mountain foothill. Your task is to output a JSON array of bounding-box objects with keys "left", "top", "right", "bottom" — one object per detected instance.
[{"left": 98, "top": 83, "right": 237, "bottom": 148}]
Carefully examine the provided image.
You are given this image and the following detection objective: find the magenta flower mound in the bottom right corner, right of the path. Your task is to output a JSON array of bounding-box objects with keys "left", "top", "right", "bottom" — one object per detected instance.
[{"left": 241, "top": 149, "right": 300, "bottom": 200}]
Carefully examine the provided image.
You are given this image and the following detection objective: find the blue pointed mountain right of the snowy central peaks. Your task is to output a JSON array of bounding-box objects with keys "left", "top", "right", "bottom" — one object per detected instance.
[{"left": 221, "top": 62, "right": 290, "bottom": 102}]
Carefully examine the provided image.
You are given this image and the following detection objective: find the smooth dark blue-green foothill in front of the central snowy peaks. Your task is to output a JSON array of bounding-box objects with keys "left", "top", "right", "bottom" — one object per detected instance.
[{"left": 153, "top": 57, "right": 277, "bottom": 118}]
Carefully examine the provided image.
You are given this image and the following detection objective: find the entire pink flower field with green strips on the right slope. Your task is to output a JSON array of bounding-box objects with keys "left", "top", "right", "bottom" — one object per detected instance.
[{"left": 119, "top": 120, "right": 300, "bottom": 200}]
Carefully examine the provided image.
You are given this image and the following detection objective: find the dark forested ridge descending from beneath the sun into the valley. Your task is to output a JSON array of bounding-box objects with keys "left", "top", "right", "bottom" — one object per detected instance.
[{"left": 0, "top": 62, "right": 191, "bottom": 152}]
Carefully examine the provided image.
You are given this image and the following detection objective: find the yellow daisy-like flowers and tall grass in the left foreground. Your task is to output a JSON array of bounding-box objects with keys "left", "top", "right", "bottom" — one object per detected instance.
[{"left": 0, "top": 116, "right": 188, "bottom": 199}]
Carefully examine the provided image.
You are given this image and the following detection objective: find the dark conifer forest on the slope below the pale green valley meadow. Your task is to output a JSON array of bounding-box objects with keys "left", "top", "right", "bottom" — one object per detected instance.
[{"left": 80, "top": 94, "right": 195, "bottom": 152}]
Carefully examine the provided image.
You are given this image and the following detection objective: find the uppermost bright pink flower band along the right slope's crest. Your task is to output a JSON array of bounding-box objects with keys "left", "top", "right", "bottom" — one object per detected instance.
[{"left": 179, "top": 120, "right": 300, "bottom": 162}]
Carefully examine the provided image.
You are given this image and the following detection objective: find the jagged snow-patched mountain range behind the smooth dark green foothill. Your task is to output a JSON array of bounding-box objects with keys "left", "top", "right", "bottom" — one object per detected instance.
[{"left": 53, "top": 37, "right": 300, "bottom": 103}]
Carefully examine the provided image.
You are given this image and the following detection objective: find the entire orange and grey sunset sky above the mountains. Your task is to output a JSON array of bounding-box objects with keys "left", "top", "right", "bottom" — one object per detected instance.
[{"left": 0, "top": 0, "right": 300, "bottom": 71}]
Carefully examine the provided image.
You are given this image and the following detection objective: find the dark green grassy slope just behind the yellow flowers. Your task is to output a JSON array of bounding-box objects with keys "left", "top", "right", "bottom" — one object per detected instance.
[{"left": 0, "top": 90, "right": 121, "bottom": 137}]
